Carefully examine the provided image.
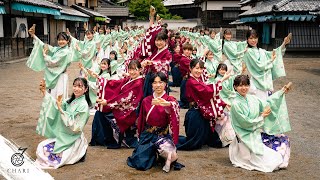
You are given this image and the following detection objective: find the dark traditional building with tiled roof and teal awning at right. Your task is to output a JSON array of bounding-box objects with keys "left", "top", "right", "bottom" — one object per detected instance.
[{"left": 239, "top": 0, "right": 320, "bottom": 51}]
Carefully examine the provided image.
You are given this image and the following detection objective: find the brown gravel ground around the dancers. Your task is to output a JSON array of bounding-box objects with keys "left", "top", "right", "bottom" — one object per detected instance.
[{"left": 0, "top": 57, "right": 320, "bottom": 179}]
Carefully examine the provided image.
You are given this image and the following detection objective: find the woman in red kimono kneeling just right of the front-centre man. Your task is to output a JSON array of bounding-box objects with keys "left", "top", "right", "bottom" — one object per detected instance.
[{"left": 177, "top": 59, "right": 230, "bottom": 150}]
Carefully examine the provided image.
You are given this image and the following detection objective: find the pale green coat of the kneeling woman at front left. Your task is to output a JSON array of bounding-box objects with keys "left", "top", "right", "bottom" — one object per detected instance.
[{"left": 36, "top": 93, "right": 89, "bottom": 153}]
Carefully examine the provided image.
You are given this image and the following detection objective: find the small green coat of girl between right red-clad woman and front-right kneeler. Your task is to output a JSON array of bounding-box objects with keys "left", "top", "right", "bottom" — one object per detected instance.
[{"left": 215, "top": 72, "right": 236, "bottom": 105}]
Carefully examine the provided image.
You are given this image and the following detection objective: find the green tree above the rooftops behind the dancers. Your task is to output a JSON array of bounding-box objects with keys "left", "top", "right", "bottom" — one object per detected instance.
[{"left": 129, "top": 0, "right": 182, "bottom": 20}]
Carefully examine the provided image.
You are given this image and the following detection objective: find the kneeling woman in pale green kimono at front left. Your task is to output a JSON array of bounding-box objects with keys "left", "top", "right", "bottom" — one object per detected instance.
[{"left": 36, "top": 78, "right": 91, "bottom": 169}]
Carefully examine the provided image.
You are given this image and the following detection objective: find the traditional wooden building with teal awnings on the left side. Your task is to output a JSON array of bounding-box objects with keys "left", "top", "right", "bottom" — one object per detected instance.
[{"left": 0, "top": 0, "right": 108, "bottom": 62}]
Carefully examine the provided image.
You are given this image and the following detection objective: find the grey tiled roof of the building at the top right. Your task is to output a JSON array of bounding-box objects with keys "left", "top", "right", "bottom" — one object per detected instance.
[{"left": 239, "top": 0, "right": 319, "bottom": 16}]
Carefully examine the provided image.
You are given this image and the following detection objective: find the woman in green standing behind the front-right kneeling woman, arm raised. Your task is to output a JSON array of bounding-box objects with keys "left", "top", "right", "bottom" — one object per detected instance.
[{"left": 243, "top": 30, "right": 291, "bottom": 100}]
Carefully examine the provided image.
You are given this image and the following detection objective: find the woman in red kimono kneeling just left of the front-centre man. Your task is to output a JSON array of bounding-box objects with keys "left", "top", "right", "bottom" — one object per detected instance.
[{"left": 90, "top": 60, "right": 144, "bottom": 148}]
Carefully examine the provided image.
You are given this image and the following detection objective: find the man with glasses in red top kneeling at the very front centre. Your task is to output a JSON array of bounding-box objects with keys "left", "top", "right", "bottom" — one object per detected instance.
[{"left": 127, "top": 72, "right": 181, "bottom": 172}]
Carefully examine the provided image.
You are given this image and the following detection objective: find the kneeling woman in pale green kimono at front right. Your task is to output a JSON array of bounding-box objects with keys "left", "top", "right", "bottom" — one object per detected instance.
[{"left": 229, "top": 75, "right": 291, "bottom": 172}]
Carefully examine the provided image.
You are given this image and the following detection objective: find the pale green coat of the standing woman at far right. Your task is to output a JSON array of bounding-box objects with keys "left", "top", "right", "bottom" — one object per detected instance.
[{"left": 243, "top": 46, "right": 286, "bottom": 91}]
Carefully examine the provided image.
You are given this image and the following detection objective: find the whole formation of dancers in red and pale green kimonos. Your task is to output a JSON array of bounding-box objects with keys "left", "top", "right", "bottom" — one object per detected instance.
[{"left": 27, "top": 8, "right": 291, "bottom": 172}]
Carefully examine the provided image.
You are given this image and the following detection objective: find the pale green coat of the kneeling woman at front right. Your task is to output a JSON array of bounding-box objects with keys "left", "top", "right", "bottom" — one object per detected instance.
[{"left": 230, "top": 90, "right": 291, "bottom": 155}]
